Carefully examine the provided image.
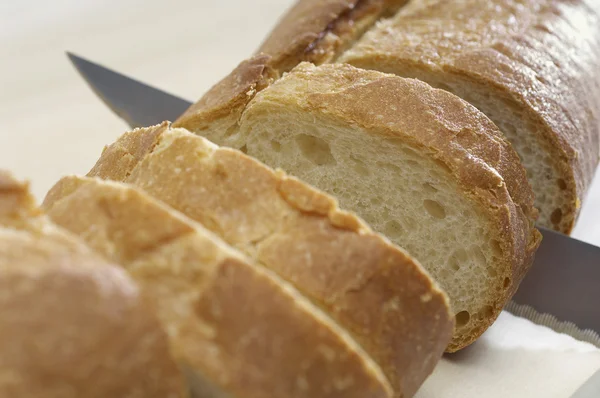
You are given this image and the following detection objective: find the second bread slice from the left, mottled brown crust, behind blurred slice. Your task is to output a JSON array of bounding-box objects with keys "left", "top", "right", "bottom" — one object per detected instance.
[{"left": 44, "top": 177, "right": 391, "bottom": 398}]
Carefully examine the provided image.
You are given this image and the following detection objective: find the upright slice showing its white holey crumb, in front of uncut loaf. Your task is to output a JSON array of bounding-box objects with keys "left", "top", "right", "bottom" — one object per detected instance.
[{"left": 172, "top": 63, "right": 540, "bottom": 351}]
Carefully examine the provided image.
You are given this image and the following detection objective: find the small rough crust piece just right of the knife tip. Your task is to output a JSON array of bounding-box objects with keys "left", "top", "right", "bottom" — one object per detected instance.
[{"left": 175, "top": 54, "right": 279, "bottom": 138}]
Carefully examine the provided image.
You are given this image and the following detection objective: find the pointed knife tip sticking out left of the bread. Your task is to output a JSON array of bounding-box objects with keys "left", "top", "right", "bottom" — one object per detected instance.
[{"left": 67, "top": 53, "right": 192, "bottom": 127}]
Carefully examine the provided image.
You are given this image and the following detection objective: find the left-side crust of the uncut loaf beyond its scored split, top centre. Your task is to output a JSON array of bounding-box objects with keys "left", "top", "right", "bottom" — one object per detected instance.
[{"left": 258, "top": 0, "right": 407, "bottom": 72}]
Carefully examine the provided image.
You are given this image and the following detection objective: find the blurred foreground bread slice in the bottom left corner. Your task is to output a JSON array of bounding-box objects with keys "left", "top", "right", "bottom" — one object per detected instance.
[{"left": 0, "top": 172, "right": 187, "bottom": 398}]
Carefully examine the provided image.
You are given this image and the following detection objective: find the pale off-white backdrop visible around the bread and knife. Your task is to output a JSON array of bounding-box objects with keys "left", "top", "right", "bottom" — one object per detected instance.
[{"left": 0, "top": 0, "right": 600, "bottom": 398}]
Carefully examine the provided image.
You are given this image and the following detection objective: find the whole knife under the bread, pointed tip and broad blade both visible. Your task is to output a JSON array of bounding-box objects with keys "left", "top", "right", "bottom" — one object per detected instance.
[{"left": 67, "top": 53, "right": 600, "bottom": 347}]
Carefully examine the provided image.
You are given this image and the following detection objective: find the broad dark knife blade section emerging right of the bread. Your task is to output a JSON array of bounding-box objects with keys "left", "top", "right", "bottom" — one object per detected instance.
[{"left": 513, "top": 228, "right": 600, "bottom": 334}]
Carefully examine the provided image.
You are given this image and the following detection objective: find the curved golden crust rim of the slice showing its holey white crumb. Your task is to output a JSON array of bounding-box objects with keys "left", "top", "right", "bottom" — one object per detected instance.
[{"left": 241, "top": 63, "right": 540, "bottom": 351}]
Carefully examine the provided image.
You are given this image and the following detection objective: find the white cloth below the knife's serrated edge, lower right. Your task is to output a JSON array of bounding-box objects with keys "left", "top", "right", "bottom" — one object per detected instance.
[{"left": 416, "top": 312, "right": 600, "bottom": 398}]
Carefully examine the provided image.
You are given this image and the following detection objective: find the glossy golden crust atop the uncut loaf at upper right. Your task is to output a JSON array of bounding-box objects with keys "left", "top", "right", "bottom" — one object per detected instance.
[{"left": 341, "top": 0, "right": 600, "bottom": 232}]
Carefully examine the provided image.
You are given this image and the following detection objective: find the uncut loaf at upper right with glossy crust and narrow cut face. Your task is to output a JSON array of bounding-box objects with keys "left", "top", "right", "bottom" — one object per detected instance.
[{"left": 339, "top": 0, "right": 600, "bottom": 233}]
